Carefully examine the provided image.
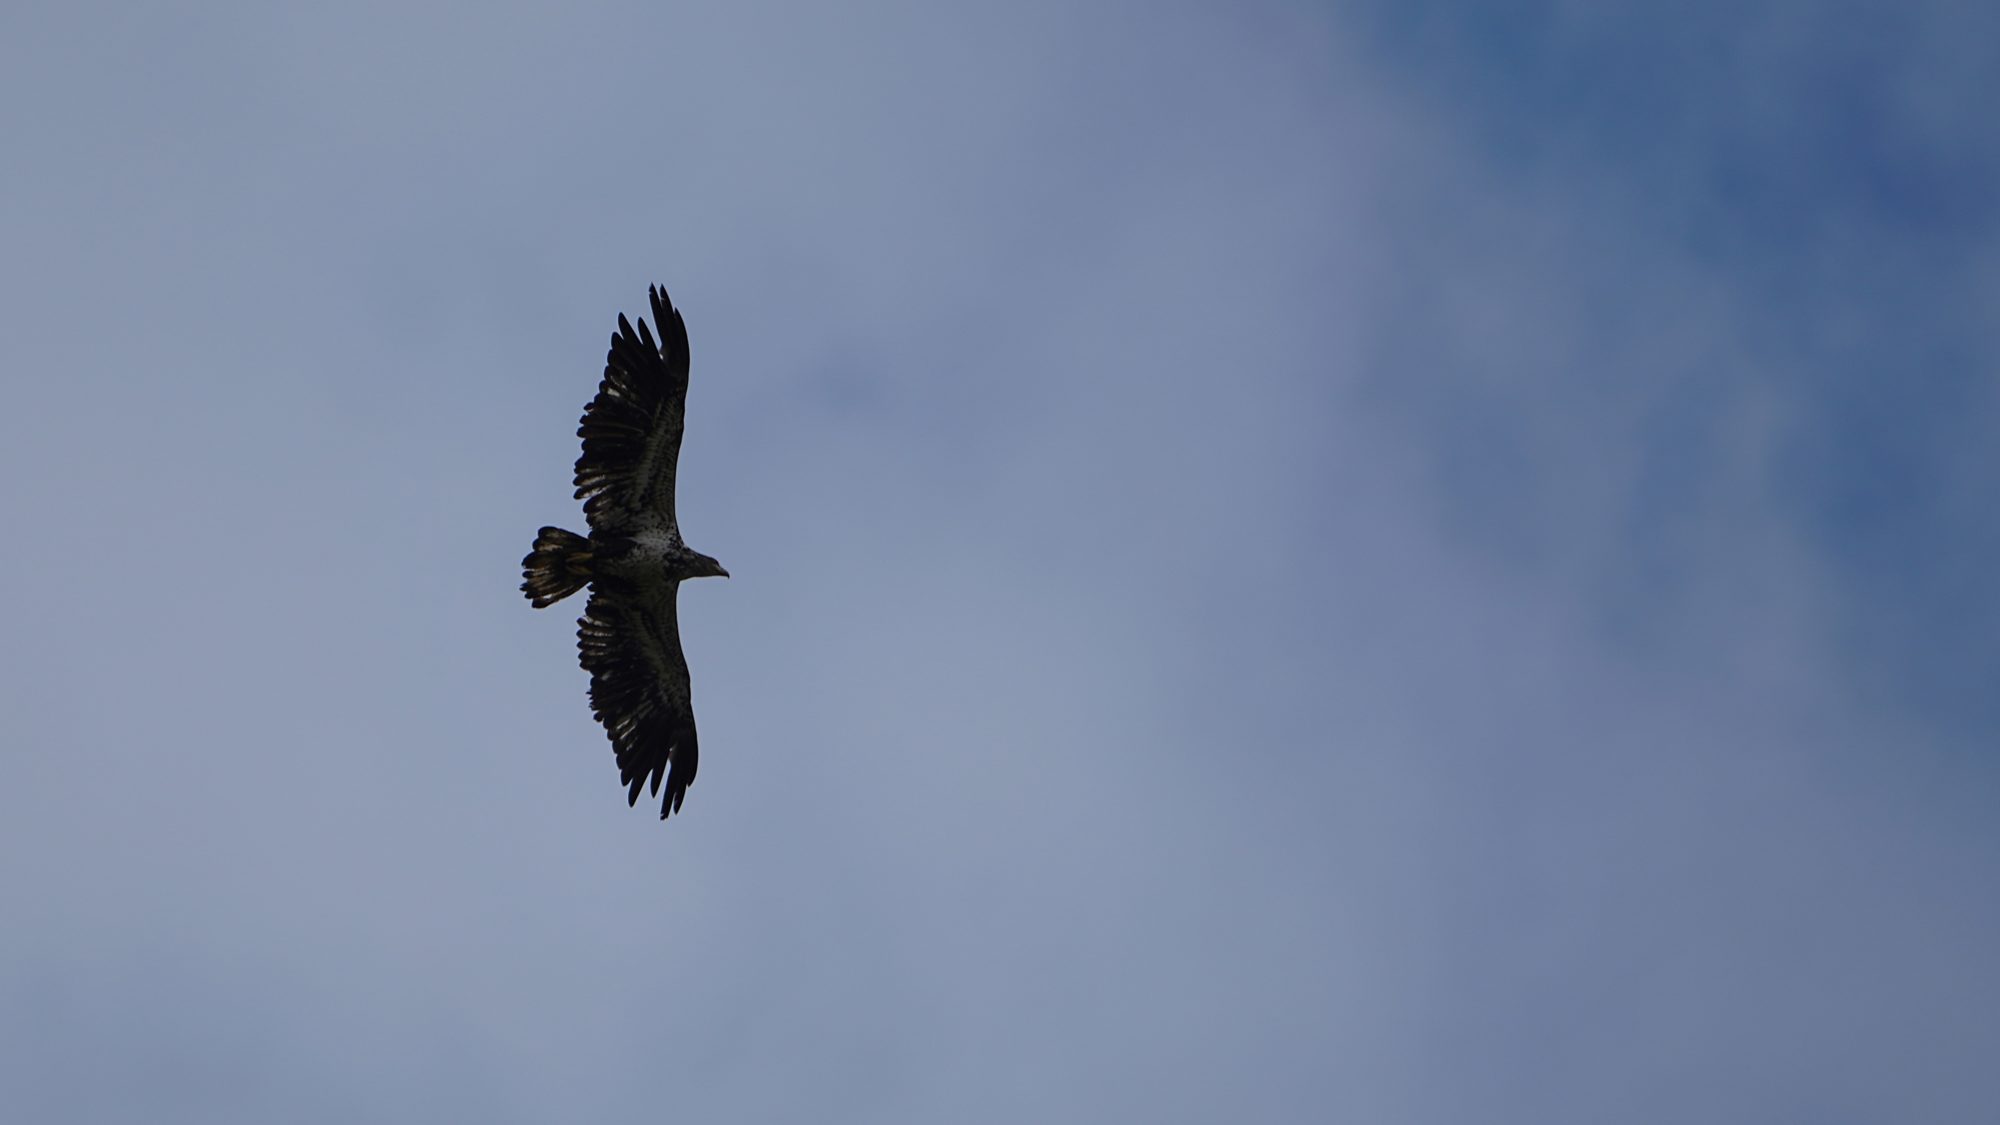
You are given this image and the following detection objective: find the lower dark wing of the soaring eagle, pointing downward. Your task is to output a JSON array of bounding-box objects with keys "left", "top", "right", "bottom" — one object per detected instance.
[{"left": 576, "top": 581, "right": 700, "bottom": 821}]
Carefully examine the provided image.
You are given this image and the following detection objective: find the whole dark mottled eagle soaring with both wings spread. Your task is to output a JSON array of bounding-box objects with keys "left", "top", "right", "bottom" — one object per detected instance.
[{"left": 520, "top": 286, "right": 730, "bottom": 821}]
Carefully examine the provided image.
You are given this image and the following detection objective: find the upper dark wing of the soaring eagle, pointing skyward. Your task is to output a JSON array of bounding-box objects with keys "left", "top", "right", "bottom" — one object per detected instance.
[{"left": 576, "top": 286, "right": 688, "bottom": 536}]
